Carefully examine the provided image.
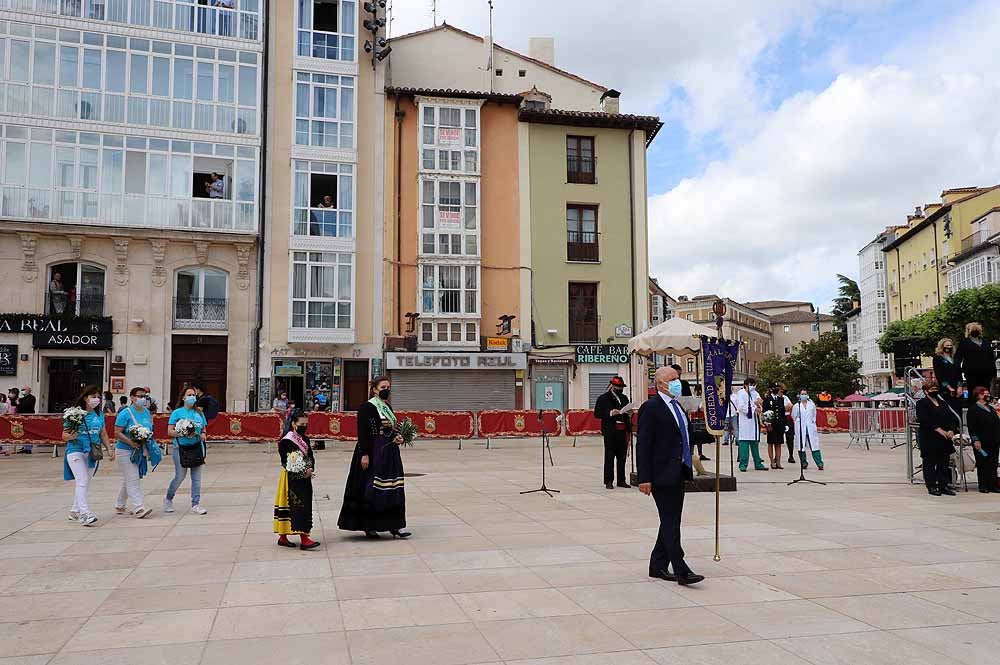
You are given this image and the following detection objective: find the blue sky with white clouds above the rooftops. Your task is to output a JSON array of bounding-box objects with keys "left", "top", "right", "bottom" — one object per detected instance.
[{"left": 391, "top": 0, "right": 1000, "bottom": 311}]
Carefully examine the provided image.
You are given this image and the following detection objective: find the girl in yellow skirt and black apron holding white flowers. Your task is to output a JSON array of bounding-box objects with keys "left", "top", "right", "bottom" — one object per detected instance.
[{"left": 274, "top": 411, "right": 319, "bottom": 550}]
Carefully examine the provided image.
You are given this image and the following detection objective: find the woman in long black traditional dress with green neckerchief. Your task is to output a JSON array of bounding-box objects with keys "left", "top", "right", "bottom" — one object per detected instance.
[{"left": 337, "top": 376, "right": 410, "bottom": 538}]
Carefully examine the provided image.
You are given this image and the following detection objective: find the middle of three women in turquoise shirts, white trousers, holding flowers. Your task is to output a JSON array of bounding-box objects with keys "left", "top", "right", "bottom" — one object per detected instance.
[{"left": 115, "top": 388, "right": 163, "bottom": 520}]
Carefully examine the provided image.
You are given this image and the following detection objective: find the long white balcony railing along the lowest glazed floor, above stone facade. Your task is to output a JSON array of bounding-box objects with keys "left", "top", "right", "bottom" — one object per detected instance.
[{"left": 0, "top": 185, "right": 257, "bottom": 233}]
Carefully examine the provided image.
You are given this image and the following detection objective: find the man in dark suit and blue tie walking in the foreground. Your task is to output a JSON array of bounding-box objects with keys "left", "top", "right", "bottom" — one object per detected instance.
[{"left": 636, "top": 367, "right": 705, "bottom": 586}]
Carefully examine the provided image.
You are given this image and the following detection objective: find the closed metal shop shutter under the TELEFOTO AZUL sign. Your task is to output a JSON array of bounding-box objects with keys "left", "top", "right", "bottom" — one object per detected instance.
[{"left": 390, "top": 370, "right": 514, "bottom": 411}]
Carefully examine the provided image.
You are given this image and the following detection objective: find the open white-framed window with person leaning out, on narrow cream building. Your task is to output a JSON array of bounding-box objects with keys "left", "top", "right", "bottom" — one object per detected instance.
[{"left": 292, "top": 161, "right": 354, "bottom": 238}]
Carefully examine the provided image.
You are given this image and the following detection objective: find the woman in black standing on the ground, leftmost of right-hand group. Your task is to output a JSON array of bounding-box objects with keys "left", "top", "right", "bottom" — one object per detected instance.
[{"left": 916, "top": 379, "right": 960, "bottom": 496}]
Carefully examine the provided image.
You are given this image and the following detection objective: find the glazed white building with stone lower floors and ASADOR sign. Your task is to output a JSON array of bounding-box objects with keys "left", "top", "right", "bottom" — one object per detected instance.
[{"left": 0, "top": 0, "right": 265, "bottom": 412}]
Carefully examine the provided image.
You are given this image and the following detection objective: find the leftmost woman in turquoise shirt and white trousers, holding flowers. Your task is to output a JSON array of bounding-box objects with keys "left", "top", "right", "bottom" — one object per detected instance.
[{"left": 62, "top": 385, "right": 115, "bottom": 526}]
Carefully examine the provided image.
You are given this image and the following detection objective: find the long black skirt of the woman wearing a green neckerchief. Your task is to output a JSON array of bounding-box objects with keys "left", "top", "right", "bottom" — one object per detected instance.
[{"left": 337, "top": 436, "right": 406, "bottom": 531}]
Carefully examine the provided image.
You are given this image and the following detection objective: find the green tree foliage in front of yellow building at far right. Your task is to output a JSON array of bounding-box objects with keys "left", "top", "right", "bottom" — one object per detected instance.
[{"left": 878, "top": 284, "right": 1000, "bottom": 355}]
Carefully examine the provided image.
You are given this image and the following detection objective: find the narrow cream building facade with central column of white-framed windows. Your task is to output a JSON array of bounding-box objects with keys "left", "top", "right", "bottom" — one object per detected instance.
[{"left": 257, "top": 0, "right": 384, "bottom": 410}]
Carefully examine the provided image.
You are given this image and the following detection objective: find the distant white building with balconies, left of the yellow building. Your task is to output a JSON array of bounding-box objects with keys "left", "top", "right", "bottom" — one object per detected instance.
[{"left": 848, "top": 228, "right": 895, "bottom": 392}]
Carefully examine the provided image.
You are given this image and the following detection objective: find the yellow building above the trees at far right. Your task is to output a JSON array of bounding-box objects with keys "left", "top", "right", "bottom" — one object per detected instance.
[{"left": 883, "top": 185, "right": 1000, "bottom": 322}]
